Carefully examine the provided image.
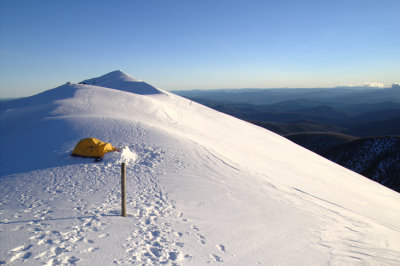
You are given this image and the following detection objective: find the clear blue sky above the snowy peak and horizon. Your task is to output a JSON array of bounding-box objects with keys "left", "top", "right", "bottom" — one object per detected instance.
[{"left": 0, "top": 0, "right": 400, "bottom": 97}]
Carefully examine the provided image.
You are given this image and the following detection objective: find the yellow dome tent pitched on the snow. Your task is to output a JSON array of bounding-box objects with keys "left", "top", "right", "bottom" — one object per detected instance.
[{"left": 71, "top": 138, "right": 118, "bottom": 158}]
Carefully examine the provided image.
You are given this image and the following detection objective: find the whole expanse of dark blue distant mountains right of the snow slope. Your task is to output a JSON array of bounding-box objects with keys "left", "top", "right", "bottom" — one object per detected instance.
[{"left": 175, "top": 86, "right": 400, "bottom": 192}]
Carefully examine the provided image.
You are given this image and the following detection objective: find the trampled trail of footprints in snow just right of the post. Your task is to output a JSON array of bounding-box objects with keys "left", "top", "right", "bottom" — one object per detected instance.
[{"left": 115, "top": 149, "right": 187, "bottom": 264}]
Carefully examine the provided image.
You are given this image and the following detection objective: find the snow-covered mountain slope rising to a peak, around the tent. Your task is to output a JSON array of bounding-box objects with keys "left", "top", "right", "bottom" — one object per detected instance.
[{"left": 0, "top": 71, "right": 400, "bottom": 265}]
